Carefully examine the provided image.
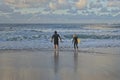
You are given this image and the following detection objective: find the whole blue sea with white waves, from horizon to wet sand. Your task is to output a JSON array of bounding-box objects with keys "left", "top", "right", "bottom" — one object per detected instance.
[{"left": 0, "top": 24, "right": 120, "bottom": 49}]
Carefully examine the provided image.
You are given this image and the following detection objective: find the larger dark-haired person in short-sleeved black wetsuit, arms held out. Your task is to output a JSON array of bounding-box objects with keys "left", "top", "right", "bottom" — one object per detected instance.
[{"left": 51, "top": 31, "right": 62, "bottom": 50}]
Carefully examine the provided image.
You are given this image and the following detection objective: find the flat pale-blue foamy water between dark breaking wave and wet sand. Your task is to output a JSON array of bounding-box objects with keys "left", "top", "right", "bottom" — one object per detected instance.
[{"left": 0, "top": 40, "right": 120, "bottom": 49}]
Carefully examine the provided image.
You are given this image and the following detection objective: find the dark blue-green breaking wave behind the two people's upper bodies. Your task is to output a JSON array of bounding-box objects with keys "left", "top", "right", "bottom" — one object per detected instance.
[{"left": 0, "top": 34, "right": 120, "bottom": 41}]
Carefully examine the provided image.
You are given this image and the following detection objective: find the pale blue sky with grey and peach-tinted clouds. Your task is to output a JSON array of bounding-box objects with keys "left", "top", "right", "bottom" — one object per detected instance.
[{"left": 0, "top": 0, "right": 120, "bottom": 23}]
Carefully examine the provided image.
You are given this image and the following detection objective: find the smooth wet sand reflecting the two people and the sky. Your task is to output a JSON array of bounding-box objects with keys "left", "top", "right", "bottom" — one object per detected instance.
[{"left": 0, "top": 48, "right": 120, "bottom": 80}]
